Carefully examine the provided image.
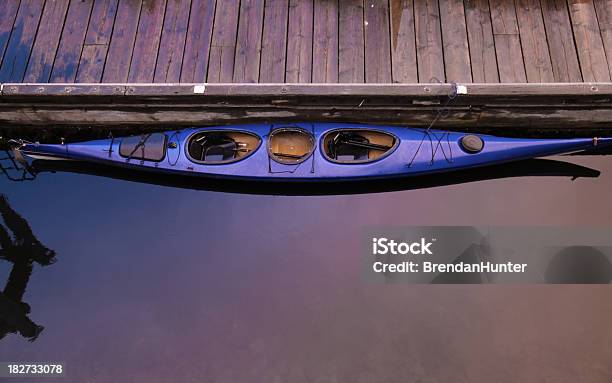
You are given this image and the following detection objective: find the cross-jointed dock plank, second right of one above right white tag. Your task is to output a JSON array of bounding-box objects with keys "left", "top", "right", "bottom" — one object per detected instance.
[{"left": 489, "top": 0, "right": 527, "bottom": 82}]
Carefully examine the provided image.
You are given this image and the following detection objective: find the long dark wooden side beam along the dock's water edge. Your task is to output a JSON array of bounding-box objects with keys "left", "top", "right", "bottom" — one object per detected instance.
[{"left": 0, "top": 83, "right": 612, "bottom": 131}]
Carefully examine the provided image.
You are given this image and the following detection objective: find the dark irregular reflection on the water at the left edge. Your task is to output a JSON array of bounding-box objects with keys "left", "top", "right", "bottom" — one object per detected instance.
[{"left": 0, "top": 194, "right": 55, "bottom": 341}]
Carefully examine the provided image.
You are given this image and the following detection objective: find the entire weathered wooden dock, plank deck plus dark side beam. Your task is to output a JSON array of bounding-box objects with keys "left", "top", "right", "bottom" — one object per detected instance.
[{"left": 0, "top": 0, "right": 612, "bottom": 128}]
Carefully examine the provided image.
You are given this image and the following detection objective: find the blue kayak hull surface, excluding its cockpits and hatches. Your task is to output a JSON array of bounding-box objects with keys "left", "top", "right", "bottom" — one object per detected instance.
[{"left": 19, "top": 123, "right": 612, "bottom": 182}]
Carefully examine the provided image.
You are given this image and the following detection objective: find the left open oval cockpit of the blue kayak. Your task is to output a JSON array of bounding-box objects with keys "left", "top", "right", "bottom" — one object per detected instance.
[{"left": 187, "top": 130, "right": 261, "bottom": 164}]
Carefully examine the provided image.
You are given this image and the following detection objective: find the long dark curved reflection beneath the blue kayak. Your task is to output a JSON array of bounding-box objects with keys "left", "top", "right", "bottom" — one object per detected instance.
[{"left": 32, "top": 159, "right": 600, "bottom": 195}]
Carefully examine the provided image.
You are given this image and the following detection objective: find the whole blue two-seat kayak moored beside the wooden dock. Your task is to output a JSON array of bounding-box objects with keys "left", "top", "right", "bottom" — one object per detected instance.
[{"left": 13, "top": 123, "right": 612, "bottom": 181}]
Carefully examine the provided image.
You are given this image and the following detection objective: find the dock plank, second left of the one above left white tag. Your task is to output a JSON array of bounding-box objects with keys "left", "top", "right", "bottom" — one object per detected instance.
[{"left": 128, "top": 0, "right": 166, "bottom": 82}]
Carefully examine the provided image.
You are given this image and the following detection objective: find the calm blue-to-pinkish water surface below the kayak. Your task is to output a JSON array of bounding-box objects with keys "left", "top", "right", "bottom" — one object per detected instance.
[{"left": 0, "top": 157, "right": 612, "bottom": 383}]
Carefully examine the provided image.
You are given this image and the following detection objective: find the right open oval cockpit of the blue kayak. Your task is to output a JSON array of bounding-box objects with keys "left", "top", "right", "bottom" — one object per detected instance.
[{"left": 323, "top": 129, "right": 399, "bottom": 164}]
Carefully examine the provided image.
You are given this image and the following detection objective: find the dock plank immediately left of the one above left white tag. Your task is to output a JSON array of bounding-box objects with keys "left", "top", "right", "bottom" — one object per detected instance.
[{"left": 154, "top": 0, "right": 191, "bottom": 82}]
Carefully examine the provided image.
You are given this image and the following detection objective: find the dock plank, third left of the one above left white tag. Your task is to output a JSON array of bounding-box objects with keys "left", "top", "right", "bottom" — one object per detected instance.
[{"left": 102, "top": 0, "right": 142, "bottom": 83}]
